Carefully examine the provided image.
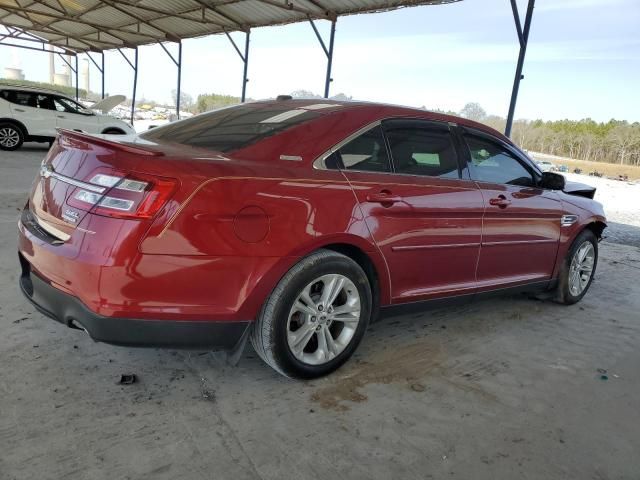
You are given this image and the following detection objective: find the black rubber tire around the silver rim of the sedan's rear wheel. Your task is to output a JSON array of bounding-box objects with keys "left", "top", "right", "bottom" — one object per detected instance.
[{"left": 272, "top": 255, "right": 372, "bottom": 378}]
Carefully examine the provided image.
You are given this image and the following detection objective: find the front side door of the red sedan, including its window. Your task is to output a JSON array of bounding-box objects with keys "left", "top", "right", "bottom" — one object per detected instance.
[{"left": 462, "top": 129, "right": 562, "bottom": 291}]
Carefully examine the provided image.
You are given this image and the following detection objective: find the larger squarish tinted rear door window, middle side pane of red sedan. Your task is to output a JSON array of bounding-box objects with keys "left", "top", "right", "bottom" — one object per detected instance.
[{"left": 387, "top": 125, "right": 459, "bottom": 179}]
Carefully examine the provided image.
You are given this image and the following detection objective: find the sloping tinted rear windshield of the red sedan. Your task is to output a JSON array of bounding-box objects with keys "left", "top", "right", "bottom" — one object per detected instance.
[{"left": 141, "top": 101, "right": 320, "bottom": 152}]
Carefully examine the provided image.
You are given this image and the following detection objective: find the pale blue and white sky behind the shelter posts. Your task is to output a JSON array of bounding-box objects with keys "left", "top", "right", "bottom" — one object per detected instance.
[{"left": 0, "top": 0, "right": 640, "bottom": 122}]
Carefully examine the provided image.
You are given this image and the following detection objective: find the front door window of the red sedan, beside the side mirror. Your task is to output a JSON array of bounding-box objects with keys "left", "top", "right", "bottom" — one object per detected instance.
[{"left": 464, "top": 134, "right": 535, "bottom": 187}]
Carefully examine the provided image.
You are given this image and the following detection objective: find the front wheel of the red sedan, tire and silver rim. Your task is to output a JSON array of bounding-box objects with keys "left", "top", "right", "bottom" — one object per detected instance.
[{"left": 556, "top": 229, "right": 598, "bottom": 305}]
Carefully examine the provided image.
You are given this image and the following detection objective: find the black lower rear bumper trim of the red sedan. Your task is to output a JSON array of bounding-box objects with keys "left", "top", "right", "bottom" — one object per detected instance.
[{"left": 20, "top": 255, "right": 251, "bottom": 350}]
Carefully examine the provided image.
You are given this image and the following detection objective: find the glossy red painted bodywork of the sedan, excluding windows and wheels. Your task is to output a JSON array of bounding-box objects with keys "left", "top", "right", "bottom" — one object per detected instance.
[{"left": 19, "top": 101, "right": 604, "bottom": 334}]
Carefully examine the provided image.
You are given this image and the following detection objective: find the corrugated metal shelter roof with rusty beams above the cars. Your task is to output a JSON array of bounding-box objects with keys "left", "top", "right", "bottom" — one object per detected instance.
[{"left": 0, "top": 0, "right": 461, "bottom": 52}]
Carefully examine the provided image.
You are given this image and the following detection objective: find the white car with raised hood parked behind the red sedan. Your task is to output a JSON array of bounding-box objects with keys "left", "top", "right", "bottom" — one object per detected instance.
[{"left": 0, "top": 85, "right": 135, "bottom": 150}]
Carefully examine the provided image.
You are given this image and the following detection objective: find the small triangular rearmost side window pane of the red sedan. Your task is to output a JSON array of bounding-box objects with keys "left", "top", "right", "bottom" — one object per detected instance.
[{"left": 329, "top": 126, "right": 391, "bottom": 172}]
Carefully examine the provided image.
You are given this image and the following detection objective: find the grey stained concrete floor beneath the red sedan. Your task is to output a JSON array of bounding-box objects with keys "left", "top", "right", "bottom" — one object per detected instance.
[{"left": 0, "top": 143, "right": 640, "bottom": 480}]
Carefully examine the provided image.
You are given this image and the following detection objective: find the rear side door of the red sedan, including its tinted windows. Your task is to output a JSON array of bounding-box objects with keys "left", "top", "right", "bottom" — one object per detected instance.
[{"left": 334, "top": 119, "right": 483, "bottom": 303}]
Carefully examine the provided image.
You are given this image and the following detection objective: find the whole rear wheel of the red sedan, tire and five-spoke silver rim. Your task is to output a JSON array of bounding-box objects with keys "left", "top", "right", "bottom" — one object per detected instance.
[{"left": 250, "top": 250, "right": 372, "bottom": 379}]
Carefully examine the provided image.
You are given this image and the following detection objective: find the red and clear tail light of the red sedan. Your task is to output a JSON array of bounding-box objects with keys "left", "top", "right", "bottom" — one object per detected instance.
[{"left": 67, "top": 173, "right": 176, "bottom": 219}]
